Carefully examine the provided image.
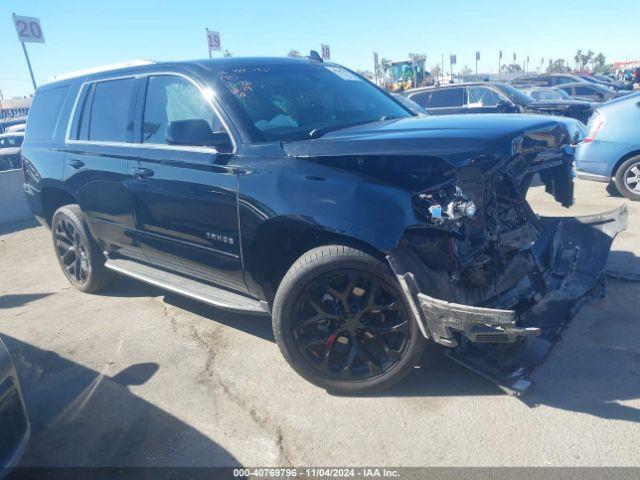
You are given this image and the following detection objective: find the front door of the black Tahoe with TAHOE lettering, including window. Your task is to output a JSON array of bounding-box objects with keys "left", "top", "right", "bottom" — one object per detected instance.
[{"left": 129, "top": 74, "right": 246, "bottom": 291}]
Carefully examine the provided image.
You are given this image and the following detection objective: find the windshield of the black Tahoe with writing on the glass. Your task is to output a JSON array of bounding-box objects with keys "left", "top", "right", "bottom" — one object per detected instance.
[{"left": 215, "top": 64, "right": 411, "bottom": 141}]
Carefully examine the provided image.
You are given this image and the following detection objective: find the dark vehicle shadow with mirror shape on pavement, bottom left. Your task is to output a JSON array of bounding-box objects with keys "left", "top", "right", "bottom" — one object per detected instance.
[{"left": 2, "top": 335, "right": 239, "bottom": 468}]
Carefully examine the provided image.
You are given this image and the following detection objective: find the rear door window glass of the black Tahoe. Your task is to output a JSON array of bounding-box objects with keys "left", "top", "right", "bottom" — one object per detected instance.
[{"left": 76, "top": 78, "right": 135, "bottom": 142}]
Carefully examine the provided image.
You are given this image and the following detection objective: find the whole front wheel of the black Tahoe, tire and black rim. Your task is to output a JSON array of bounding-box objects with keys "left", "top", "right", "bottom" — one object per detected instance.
[{"left": 273, "top": 245, "right": 426, "bottom": 394}]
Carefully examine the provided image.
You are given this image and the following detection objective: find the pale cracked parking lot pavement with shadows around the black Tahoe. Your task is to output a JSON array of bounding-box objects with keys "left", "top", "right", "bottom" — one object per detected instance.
[{"left": 0, "top": 178, "right": 640, "bottom": 466}]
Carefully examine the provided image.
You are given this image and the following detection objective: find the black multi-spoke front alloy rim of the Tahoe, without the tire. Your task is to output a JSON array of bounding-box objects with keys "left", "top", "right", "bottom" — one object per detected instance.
[{"left": 292, "top": 269, "right": 411, "bottom": 380}]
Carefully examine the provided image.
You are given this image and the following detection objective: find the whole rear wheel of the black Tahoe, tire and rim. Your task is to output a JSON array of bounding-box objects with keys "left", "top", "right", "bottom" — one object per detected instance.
[{"left": 51, "top": 205, "right": 113, "bottom": 293}]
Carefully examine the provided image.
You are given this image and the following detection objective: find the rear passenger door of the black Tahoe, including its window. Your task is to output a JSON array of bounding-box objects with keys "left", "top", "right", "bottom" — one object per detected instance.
[{"left": 64, "top": 76, "right": 137, "bottom": 251}]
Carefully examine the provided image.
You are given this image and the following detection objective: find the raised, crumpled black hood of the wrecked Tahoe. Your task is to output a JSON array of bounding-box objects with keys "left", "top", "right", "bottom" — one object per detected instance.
[{"left": 282, "top": 114, "right": 584, "bottom": 165}]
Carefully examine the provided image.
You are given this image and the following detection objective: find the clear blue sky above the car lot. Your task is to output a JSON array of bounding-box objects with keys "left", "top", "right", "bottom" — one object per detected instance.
[{"left": 0, "top": 0, "right": 640, "bottom": 98}]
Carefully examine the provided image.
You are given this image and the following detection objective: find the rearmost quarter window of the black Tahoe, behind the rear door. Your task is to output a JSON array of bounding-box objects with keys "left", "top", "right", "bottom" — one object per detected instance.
[{"left": 25, "top": 85, "right": 69, "bottom": 141}]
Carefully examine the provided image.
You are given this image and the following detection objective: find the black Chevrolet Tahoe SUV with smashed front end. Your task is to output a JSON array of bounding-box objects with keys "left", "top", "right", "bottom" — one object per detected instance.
[{"left": 22, "top": 58, "right": 626, "bottom": 392}]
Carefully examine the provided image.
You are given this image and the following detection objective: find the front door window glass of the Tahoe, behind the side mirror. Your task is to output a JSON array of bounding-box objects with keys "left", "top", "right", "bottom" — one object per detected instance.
[{"left": 142, "top": 75, "right": 224, "bottom": 144}]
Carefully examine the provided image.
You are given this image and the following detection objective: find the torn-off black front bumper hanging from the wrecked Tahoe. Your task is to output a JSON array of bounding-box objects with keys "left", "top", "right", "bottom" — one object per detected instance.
[{"left": 388, "top": 205, "right": 627, "bottom": 394}]
